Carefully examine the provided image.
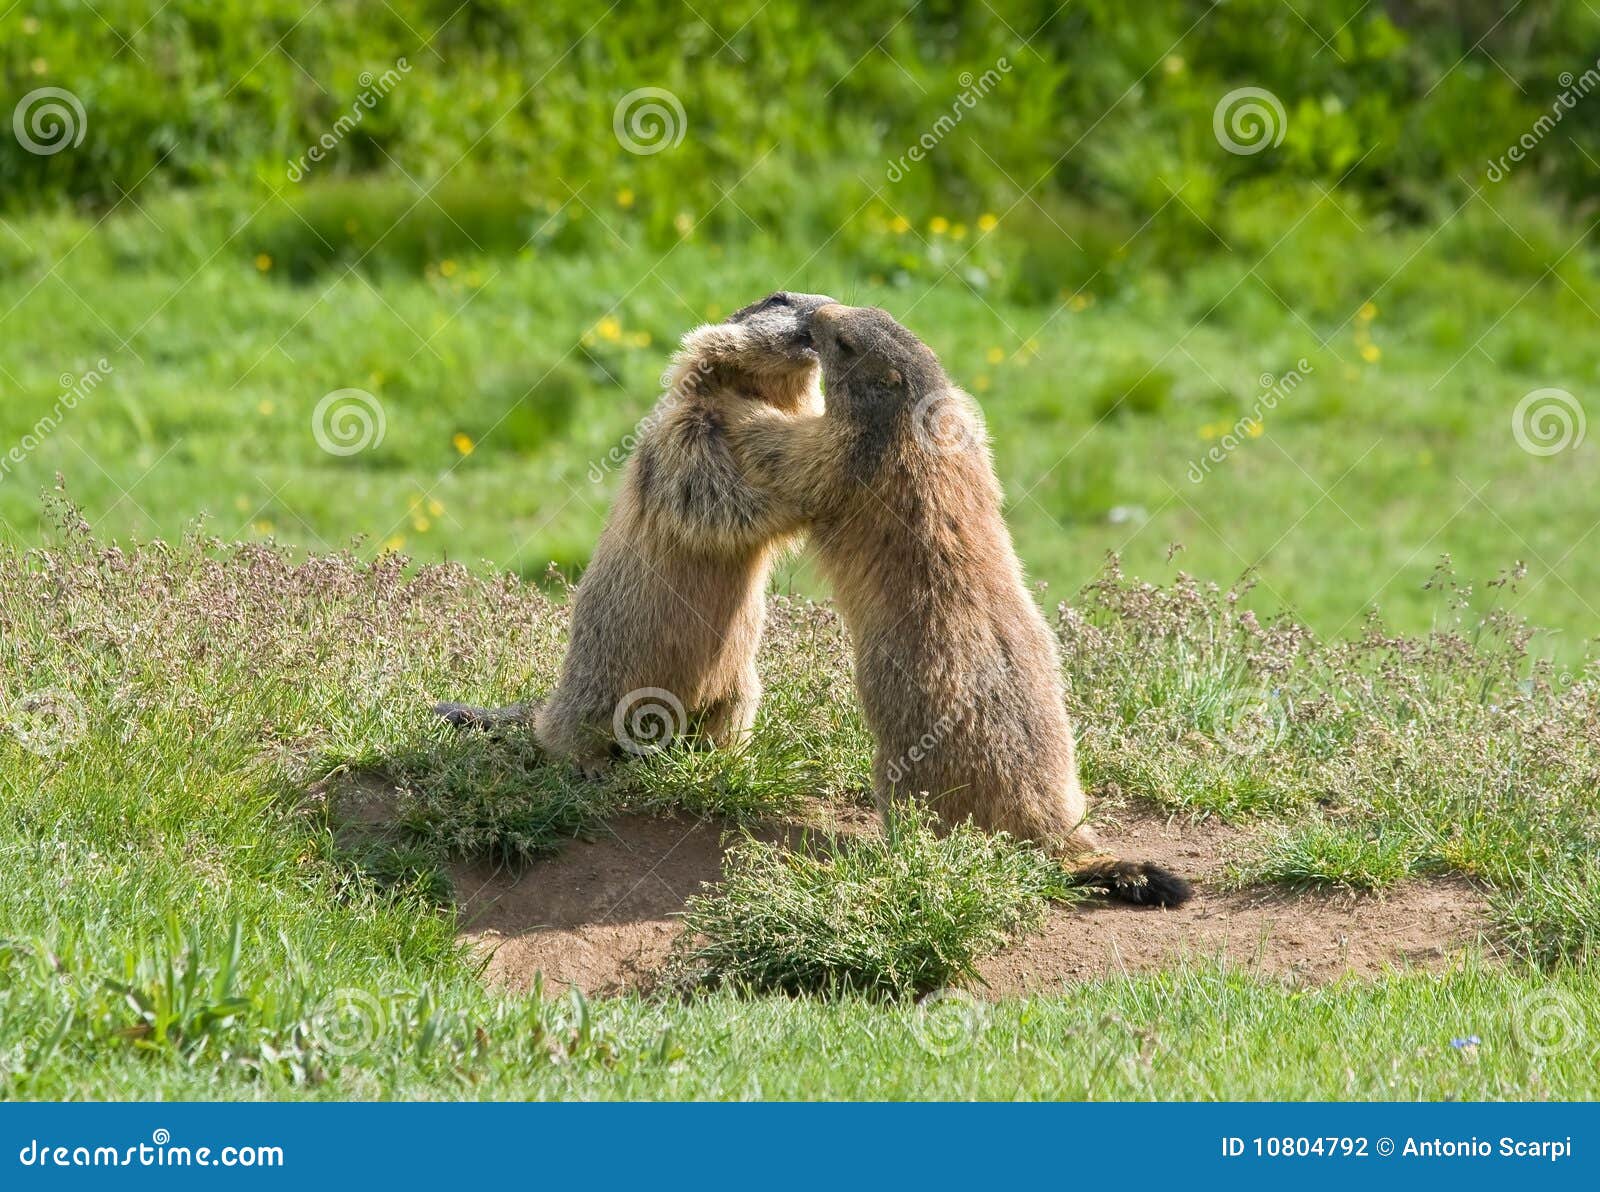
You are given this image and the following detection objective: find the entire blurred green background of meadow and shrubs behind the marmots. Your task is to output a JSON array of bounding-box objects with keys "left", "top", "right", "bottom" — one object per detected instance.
[{"left": 0, "top": 0, "right": 1600, "bottom": 656}]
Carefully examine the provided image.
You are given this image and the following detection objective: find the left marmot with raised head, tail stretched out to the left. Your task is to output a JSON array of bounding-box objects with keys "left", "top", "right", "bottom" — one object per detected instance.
[{"left": 435, "top": 291, "right": 834, "bottom": 778}]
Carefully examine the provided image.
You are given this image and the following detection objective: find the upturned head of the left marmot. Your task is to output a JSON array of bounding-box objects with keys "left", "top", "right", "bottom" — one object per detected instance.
[{"left": 667, "top": 290, "right": 834, "bottom": 406}]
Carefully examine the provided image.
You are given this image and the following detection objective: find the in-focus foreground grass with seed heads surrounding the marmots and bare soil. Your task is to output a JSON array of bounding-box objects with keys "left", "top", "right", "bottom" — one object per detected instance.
[{"left": 0, "top": 521, "right": 1600, "bottom": 1098}]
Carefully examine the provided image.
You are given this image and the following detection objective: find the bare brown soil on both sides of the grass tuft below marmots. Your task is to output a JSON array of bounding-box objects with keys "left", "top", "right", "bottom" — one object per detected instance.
[{"left": 453, "top": 813, "right": 1485, "bottom": 997}]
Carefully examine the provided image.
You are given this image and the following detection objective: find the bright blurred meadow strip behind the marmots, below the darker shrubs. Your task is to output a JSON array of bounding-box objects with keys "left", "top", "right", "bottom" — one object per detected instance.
[{"left": 9, "top": 184, "right": 1600, "bottom": 659}]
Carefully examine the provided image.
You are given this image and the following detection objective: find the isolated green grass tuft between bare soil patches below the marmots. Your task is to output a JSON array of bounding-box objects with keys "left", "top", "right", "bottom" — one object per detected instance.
[{"left": 675, "top": 808, "right": 1080, "bottom": 997}]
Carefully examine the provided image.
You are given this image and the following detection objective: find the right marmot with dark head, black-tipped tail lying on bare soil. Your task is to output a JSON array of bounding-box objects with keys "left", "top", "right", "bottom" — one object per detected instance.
[{"left": 730, "top": 304, "right": 1190, "bottom": 906}]
